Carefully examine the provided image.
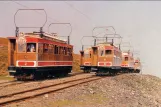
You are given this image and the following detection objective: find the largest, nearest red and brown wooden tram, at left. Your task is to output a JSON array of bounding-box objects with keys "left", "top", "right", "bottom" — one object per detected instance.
[{"left": 8, "top": 33, "right": 73, "bottom": 80}]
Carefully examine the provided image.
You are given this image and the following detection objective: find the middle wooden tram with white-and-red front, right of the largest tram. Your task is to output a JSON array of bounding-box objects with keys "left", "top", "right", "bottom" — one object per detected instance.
[{"left": 91, "top": 43, "right": 122, "bottom": 76}]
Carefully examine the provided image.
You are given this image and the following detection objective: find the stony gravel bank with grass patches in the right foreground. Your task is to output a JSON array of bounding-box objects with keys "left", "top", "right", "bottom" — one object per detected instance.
[{"left": 1, "top": 74, "right": 161, "bottom": 107}]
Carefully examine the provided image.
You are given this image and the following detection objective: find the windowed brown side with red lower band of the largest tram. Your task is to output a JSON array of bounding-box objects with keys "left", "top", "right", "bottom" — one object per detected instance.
[{"left": 37, "top": 38, "right": 73, "bottom": 76}]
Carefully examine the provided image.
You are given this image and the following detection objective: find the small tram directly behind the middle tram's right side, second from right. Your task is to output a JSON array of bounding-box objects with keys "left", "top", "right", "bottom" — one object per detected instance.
[{"left": 121, "top": 51, "right": 134, "bottom": 73}]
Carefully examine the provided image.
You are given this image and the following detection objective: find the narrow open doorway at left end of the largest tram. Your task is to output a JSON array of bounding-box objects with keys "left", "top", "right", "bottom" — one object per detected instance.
[{"left": 9, "top": 39, "right": 16, "bottom": 66}]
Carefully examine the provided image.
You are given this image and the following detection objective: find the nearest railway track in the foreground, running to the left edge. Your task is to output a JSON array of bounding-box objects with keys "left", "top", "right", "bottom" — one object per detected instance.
[{"left": 0, "top": 76, "right": 103, "bottom": 106}]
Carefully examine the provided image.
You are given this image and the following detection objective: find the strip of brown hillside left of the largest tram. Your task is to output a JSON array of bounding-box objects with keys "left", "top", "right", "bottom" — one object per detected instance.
[{"left": 0, "top": 38, "right": 8, "bottom": 75}]
